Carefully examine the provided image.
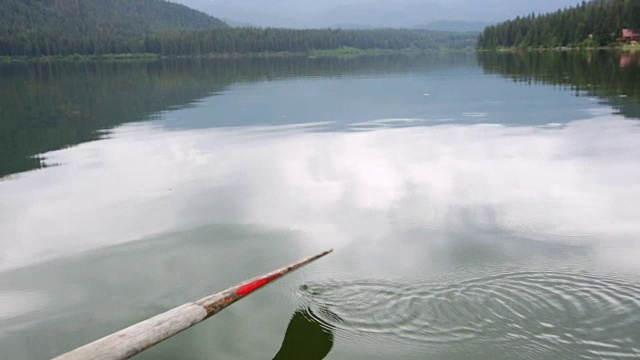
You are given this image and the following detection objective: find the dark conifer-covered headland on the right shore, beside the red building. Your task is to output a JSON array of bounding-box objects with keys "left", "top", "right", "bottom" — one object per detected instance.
[{"left": 478, "top": 0, "right": 640, "bottom": 49}]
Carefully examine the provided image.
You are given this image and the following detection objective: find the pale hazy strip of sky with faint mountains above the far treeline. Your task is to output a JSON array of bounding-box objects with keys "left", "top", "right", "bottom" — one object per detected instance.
[{"left": 173, "top": 0, "right": 579, "bottom": 27}]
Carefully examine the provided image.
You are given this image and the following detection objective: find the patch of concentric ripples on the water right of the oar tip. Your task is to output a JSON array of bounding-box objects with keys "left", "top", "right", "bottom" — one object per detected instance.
[{"left": 297, "top": 272, "right": 640, "bottom": 358}]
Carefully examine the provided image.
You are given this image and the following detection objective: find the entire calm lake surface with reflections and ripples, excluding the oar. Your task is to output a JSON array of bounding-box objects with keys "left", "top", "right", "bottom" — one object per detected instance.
[{"left": 0, "top": 52, "right": 640, "bottom": 360}]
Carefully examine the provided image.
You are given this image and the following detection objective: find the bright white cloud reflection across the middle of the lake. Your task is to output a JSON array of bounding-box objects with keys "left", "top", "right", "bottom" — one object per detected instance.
[{"left": 0, "top": 115, "right": 640, "bottom": 270}]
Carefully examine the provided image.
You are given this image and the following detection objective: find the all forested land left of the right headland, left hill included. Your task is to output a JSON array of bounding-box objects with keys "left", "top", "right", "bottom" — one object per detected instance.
[{"left": 0, "top": 0, "right": 477, "bottom": 58}]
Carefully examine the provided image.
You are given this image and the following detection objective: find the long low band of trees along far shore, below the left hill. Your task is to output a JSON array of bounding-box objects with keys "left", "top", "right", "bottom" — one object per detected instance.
[{"left": 0, "top": 28, "right": 476, "bottom": 56}]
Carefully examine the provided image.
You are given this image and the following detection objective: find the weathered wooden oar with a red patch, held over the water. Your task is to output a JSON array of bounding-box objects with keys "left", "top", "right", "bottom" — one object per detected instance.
[{"left": 54, "top": 250, "right": 333, "bottom": 360}]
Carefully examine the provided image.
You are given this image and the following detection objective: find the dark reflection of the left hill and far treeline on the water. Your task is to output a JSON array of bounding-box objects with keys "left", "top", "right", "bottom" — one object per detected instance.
[{"left": 0, "top": 53, "right": 473, "bottom": 178}]
